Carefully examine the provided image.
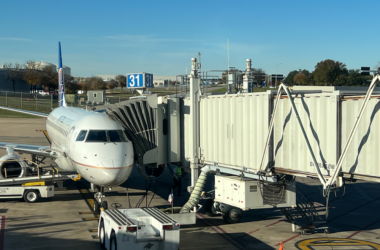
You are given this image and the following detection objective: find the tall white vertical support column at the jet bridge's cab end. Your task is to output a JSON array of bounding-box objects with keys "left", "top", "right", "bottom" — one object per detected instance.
[{"left": 188, "top": 58, "right": 200, "bottom": 200}]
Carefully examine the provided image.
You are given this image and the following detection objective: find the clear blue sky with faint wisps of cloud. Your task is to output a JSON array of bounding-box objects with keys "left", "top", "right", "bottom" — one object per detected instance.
[{"left": 0, "top": 0, "right": 380, "bottom": 77}]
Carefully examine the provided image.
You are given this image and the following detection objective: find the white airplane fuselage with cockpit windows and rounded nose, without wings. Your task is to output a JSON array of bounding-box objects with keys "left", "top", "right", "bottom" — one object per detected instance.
[{"left": 46, "top": 107, "right": 133, "bottom": 187}]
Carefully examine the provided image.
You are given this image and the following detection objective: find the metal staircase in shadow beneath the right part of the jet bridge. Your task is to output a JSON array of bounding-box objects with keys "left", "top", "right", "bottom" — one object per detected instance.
[{"left": 281, "top": 187, "right": 328, "bottom": 234}]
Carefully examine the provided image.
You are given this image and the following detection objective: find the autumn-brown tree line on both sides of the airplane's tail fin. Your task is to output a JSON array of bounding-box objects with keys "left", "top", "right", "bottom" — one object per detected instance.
[{"left": 3, "top": 60, "right": 127, "bottom": 94}]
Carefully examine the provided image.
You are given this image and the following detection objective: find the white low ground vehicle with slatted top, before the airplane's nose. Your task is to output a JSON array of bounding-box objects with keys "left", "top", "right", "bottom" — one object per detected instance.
[{"left": 98, "top": 207, "right": 180, "bottom": 250}]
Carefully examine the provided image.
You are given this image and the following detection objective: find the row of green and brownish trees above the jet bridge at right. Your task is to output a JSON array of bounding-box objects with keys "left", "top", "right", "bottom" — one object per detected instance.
[{"left": 284, "top": 59, "right": 380, "bottom": 86}]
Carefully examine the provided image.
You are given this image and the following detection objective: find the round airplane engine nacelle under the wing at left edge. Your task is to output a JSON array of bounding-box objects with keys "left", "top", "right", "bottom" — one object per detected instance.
[{"left": 0, "top": 154, "right": 28, "bottom": 179}]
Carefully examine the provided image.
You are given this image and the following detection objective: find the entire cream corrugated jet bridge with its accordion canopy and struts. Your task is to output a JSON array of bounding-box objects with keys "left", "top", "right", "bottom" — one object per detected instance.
[{"left": 106, "top": 59, "right": 380, "bottom": 228}]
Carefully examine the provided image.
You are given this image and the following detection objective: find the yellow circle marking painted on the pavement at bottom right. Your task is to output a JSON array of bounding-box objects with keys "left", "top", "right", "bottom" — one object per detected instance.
[{"left": 294, "top": 238, "right": 380, "bottom": 250}]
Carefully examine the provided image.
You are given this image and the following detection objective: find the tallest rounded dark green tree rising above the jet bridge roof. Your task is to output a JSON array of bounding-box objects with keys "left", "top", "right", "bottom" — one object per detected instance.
[{"left": 313, "top": 59, "right": 348, "bottom": 85}]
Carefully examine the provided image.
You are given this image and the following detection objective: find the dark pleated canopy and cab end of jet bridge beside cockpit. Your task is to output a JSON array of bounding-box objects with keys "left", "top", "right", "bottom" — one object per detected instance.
[{"left": 105, "top": 95, "right": 183, "bottom": 177}]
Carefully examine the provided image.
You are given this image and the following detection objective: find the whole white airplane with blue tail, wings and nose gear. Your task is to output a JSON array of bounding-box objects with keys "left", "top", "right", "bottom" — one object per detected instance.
[{"left": 0, "top": 42, "right": 134, "bottom": 212}]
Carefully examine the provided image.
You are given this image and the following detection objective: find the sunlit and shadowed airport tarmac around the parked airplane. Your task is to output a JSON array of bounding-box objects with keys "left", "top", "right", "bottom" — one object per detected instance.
[{"left": 0, "top": 118, "right": 380, "bottom": 250}]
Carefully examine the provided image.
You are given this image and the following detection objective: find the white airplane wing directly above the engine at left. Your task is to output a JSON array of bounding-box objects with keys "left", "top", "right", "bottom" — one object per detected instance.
[{"left": 0, "top": 142, "right": 59, "bottom": 158}]
